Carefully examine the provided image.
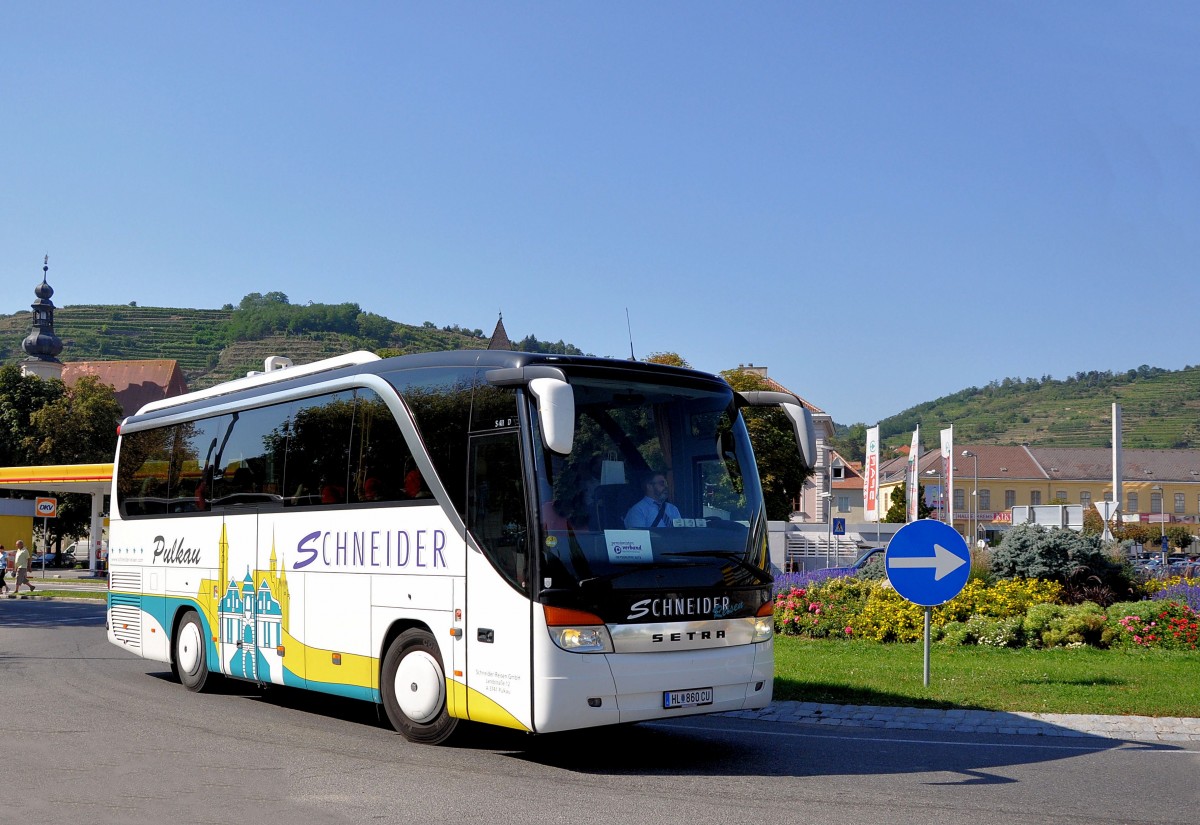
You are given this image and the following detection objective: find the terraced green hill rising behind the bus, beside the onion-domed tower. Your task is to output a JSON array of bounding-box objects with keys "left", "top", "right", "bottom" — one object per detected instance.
[{"left": 0, "top": 293, "right": 581, "bottom": 390}]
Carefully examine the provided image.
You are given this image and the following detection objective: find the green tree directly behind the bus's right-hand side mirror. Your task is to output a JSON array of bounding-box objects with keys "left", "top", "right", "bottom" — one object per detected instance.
[{"left": 715, "top": 369, "right": 812, "bottom": 522}]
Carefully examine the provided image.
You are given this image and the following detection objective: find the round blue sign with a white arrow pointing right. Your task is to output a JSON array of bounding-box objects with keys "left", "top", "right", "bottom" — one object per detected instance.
[{"left": 883, "top": 518, "right": 971, "bottom": 607}]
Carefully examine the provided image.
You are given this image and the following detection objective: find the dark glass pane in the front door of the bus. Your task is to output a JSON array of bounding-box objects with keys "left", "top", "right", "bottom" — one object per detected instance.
[{"left": 467, "top": 432, "right": 529, "bottom": 592}]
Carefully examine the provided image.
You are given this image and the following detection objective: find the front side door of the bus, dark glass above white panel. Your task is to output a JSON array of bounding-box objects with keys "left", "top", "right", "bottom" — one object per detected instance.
[{"left": 466, "top": 428, "right": 533, "bottom": 730}]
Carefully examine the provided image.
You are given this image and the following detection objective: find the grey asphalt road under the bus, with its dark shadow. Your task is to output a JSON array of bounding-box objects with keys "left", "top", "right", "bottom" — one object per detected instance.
[{"left": 0, "top": 600, "right": 1200, "bottom": 825}]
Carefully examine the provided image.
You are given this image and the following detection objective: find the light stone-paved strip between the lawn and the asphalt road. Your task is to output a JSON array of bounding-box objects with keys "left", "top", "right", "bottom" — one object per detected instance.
[{"left": 726, "top": 701, "right": 1200, "bottom": 742}]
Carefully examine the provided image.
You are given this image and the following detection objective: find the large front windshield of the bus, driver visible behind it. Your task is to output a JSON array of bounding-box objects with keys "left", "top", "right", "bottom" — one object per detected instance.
[{"left": 530, "top": 377, "right": 770, "bottom": 607}]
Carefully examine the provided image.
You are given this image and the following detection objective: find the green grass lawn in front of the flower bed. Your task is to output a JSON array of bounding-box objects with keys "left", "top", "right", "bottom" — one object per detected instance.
[{"left": 775, "top": 636, "right": 1200, "bottom": 717}]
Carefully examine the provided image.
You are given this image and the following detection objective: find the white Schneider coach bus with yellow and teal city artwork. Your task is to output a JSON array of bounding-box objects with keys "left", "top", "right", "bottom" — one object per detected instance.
[{"left": 108, "top": 350, "right": 812, "bottom": 742}]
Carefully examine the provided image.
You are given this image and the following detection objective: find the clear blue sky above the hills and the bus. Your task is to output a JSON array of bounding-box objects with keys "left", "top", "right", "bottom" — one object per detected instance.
[{"left": 0, "top": 1, "right": 1200, "bottom": 423}]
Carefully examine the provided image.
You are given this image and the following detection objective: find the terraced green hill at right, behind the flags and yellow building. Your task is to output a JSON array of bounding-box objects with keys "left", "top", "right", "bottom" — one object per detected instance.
[{"left": 880, "top": 366, "right": 1200, "bottom": 448}]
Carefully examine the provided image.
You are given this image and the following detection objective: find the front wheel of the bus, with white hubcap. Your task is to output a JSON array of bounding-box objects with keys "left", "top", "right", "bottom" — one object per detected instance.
[{"left": 379, "top": 627, "right": 458, "bottom": 745}]
